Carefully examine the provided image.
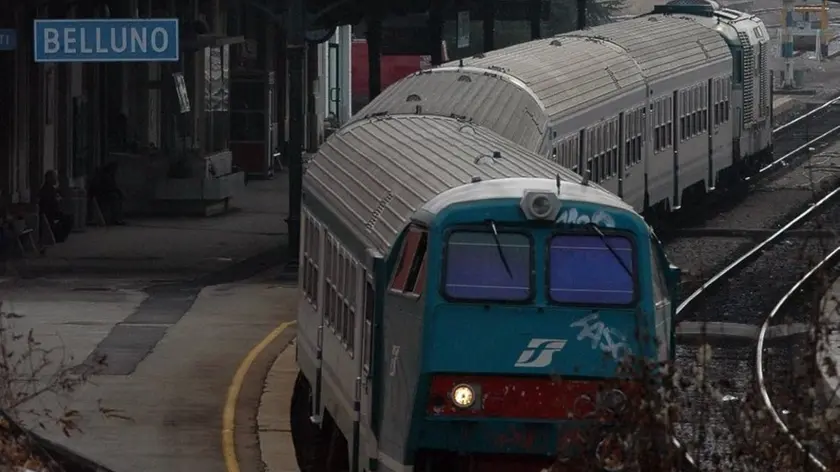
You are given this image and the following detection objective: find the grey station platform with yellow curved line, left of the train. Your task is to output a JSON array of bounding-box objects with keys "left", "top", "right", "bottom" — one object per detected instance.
[{"left": 0, "top": 174, "right": 297, "bottom": 472}]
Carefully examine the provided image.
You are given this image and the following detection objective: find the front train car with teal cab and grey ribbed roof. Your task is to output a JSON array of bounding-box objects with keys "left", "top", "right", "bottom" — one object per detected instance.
[{"left": 290, "top": 114, "right": 679, "bottom": 472}]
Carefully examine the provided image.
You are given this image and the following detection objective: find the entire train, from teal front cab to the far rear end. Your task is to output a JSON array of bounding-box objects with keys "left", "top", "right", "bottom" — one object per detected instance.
[{"left": 290, "top": 0, "right": 772, "bottom": 472}]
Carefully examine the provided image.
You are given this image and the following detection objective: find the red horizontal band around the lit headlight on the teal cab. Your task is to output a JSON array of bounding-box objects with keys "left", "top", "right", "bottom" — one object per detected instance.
[{"left": 426, "top": 375, "right": 633, "bottom": 420}]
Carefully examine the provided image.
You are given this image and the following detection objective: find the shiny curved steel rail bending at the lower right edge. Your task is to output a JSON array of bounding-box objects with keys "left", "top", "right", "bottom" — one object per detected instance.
[{"left": 755, "top": 246, "right": 840, "bottom": 471}]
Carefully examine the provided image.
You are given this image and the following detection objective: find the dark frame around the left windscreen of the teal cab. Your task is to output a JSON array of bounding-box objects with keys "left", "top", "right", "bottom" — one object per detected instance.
[{"left": 438, "top": 227, "right": 537, "bottom": 305}]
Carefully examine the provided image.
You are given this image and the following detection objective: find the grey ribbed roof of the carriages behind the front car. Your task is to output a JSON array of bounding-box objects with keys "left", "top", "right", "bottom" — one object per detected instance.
[{"left": 356, "top": 14, "right": 730, "bottom": 149}]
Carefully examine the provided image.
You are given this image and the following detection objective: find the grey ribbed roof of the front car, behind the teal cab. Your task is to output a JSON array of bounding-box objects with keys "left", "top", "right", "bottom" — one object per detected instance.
[{"left": 304, "top": 115, "right": 633, "bottom": 253}]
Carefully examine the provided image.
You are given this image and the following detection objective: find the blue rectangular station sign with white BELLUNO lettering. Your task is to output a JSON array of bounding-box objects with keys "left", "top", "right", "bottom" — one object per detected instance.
[{"left": 34, "top": 18, "right": 180, "bottom": 62}]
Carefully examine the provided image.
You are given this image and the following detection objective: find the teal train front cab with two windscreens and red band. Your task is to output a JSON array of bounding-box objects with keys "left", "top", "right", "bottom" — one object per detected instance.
[{"left": 377, "top": 184, "right": 679, "bottom": 472}]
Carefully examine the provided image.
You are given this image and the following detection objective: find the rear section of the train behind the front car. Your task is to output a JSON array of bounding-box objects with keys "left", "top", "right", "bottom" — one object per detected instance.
[{"left": 356, "top": 0, "right": 772, "bottom": 213}]
